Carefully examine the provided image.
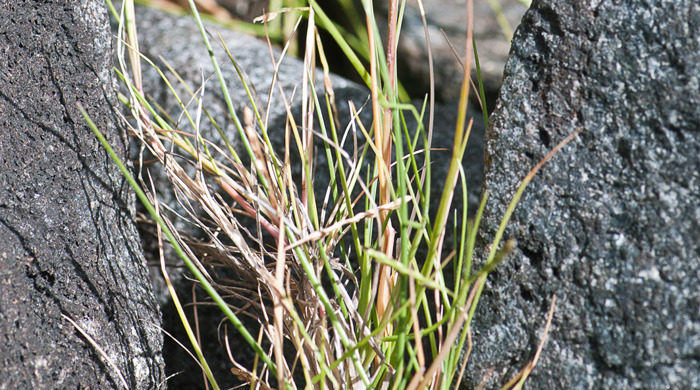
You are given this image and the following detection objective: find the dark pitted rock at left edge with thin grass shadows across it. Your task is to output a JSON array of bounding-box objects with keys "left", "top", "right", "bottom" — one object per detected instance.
[{"left": 0, "top": 0, "right": 164, "bottom": 389}]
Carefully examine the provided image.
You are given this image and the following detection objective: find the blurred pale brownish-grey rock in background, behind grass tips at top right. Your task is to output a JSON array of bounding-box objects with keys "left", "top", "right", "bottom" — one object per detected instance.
[{"left": 379, "top": 0, "right": 527, "bottom": 108}]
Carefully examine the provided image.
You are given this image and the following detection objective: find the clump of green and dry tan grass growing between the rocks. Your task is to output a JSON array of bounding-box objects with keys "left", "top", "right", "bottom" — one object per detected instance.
[{"left": 80, "top": 0, "right": 576, "bottom": 389}]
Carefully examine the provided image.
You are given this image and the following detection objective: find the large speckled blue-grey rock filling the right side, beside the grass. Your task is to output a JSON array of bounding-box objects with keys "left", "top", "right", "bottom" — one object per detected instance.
[{"left": 467, "top": 0, "right": 700, "bottom": 389}]
